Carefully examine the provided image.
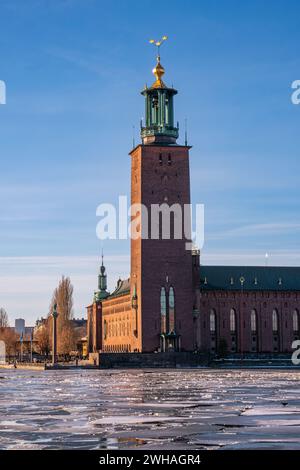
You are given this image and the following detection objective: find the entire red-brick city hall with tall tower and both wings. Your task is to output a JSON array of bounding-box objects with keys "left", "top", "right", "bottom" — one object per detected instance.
[{"left": 87, "top": 37, "right": 300, "bottom": 355}]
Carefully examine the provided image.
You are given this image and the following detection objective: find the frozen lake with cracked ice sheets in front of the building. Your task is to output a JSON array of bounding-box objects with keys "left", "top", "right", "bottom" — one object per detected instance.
[{"left": 0, "top": 369, "right": 300, "bottom": 450}]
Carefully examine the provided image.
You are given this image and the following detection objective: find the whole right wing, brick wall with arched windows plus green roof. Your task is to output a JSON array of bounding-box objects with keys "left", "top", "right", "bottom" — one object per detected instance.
[{"left": 195, "top": 266, "right": 300, "bottom": 354}]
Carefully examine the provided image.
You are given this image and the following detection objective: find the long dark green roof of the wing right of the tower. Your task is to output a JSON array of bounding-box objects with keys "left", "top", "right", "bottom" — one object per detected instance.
[{"left": 200, "top": 265, "right": 300, "bottom": 291}]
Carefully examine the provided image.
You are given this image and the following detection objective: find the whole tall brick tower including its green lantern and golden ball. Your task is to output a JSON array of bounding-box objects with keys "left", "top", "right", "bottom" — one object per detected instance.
[{"left": 130, "top": 45, "right": 194, "bottom": 352}]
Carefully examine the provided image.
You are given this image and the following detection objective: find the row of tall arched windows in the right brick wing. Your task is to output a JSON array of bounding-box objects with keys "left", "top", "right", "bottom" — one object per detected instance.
[{"left": 209, "top": 308, "right": 299, "bottom": 333}]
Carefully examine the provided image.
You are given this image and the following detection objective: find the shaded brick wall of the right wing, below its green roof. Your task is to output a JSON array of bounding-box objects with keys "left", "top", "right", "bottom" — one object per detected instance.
[{"left": 196, "top": 291, "right": 300, "bottom": 353}]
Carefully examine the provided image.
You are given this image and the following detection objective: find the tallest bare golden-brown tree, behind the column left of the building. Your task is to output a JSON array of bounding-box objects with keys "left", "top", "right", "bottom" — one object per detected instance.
[{"left": 50, "top": 276, "right": 76, "bottom": 355}]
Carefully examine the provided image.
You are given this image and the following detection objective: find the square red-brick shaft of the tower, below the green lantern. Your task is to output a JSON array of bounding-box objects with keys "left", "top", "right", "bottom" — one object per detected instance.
[{"left": 131, "top": 145, "right": 193, "bottom": 352}]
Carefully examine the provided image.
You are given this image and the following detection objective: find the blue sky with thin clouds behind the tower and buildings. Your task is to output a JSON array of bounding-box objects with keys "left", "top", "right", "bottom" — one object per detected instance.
[{"left": 0, "top": 0, "right": 300, "bottom": 323}]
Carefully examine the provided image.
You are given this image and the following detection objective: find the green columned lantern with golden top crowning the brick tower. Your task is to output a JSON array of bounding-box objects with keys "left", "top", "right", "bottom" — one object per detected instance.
[{"left": 141, "top": 36, "right": 178, "bottom": 145}]
